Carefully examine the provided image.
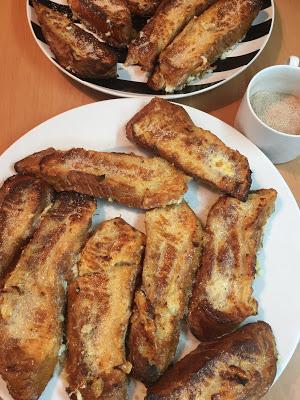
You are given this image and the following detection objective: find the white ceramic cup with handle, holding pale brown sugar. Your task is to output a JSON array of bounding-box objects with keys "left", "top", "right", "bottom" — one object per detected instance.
[{"left": 234, "top": 56, "right": 300, "bottom": 164}]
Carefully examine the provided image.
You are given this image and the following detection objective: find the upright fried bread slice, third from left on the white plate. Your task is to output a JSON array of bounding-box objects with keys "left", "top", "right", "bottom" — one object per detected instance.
[{"left": 66, "top": 218, "right": 144, "bottom": 400}]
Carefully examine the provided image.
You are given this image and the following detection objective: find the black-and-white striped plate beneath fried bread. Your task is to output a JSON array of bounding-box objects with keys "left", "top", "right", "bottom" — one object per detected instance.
[{"left": 27, "top": 0, "right": 274, "bottom": 99}]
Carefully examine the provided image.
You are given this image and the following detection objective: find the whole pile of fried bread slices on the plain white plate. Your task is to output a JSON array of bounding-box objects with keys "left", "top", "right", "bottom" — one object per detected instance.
[{"left": 0, "top": 99, "right": 277, "bottom": 400}]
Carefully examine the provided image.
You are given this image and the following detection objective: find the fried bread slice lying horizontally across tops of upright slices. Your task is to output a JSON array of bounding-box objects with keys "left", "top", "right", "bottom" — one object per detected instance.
[{"left": 17, "top": 149, "right": 189, "bottom": 209}]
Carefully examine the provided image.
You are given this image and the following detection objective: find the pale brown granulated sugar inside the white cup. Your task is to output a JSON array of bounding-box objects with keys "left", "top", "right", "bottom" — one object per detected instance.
[{"left": 250, "top": 90, "right": 300, "bottom": 135}]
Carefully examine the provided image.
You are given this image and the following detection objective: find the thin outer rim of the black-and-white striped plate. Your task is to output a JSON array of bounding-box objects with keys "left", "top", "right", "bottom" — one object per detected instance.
[{"left": 25, "top": 0, "right": 276, "bottom": 100}]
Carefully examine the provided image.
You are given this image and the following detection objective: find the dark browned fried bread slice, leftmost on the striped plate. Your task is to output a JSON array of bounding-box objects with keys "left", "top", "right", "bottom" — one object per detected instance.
[{"left": 32, "top": 0, "right": 117, "bottom": 79}]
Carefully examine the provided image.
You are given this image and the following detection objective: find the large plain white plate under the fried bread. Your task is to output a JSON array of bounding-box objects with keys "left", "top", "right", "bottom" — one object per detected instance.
[{"left": 0, "top": 98, "right": 300, "bottom": 400}]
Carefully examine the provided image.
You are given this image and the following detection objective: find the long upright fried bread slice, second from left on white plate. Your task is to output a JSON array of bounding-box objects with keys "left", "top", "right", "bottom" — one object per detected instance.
[{"left": 0, "top": 193, "right": 96, "bottom": 400}]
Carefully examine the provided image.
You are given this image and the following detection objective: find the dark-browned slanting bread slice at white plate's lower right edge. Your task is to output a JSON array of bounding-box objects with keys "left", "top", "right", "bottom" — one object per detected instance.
[{"left": 146, "top": 321, "right": 277, "bottom": 400}]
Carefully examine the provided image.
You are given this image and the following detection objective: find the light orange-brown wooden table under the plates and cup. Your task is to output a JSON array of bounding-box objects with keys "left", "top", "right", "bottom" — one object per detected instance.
[{"left": 0, "top": 0, "right": 300, "bottom": 400}]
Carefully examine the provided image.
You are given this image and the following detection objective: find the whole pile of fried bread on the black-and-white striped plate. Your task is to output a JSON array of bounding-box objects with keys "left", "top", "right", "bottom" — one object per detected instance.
[{"left": 33, "top": 0, "right": 262, "bottom": 92}]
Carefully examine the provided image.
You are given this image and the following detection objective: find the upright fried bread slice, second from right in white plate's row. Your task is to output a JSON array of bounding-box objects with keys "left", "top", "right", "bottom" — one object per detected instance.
[{"left": 128, "top": 203, "right": 202, "bottom": 383}]
